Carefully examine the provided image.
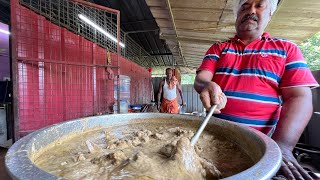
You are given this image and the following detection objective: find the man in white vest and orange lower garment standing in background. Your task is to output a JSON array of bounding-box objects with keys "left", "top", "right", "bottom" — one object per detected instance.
[{"left": 158, "top": 68, "right": 183, "bottom": 114}]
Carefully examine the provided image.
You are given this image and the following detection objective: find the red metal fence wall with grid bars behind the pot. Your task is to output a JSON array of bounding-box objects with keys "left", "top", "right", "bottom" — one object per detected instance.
[{"left": 11, "top": 0, "right": 151, "bottom": 139}]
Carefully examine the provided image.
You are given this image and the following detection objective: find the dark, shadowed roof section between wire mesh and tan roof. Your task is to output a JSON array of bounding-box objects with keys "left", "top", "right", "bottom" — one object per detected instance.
[{"left": 93, "top": 0, "right": 174, "bottom": 66}]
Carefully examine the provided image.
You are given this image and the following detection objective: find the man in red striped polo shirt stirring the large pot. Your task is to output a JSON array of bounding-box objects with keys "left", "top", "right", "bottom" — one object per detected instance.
[{"left": 194, "top": 0, "right": 319, "bottom": 179}]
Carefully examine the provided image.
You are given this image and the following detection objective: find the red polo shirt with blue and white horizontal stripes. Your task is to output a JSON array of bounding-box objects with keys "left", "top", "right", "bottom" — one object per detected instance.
[{"left": 198, "top": 33, "right": 319, "bottom": 134}]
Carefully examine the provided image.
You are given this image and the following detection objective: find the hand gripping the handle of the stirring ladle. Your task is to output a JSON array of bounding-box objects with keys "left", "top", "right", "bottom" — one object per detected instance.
[{"left": 200, "top": 82, "right": 227, "bottom": 114}]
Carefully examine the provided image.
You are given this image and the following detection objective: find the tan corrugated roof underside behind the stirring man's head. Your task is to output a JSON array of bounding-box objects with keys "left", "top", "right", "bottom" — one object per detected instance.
[{"left": 146, "top": 0, "right": 320, "bottom": 68}]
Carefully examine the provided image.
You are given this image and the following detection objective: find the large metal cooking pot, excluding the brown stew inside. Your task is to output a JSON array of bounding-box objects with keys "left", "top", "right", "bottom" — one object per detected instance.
[{"left": 5, "top": 113, "right": 282, "bottom": 180}]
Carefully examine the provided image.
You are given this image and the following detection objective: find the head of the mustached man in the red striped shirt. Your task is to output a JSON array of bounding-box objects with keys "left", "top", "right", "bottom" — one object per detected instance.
[{"left": 236, "top": 0, "right": 271, "bottom": 35}]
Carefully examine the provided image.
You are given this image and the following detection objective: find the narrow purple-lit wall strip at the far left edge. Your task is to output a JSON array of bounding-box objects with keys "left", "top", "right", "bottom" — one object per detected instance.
[{"left": 0, "top": 22, "right": 10, "bottom": 81}]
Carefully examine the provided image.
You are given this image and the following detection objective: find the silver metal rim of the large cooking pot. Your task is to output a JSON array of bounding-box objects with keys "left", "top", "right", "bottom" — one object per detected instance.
[{"left": 5, "top": 113, "right": 282, "bottom": 180}]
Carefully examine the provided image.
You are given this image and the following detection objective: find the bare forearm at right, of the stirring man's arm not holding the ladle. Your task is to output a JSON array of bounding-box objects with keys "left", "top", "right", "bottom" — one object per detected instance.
[{"left": 272, "top": 96, "right": 312, "bottom": 151}]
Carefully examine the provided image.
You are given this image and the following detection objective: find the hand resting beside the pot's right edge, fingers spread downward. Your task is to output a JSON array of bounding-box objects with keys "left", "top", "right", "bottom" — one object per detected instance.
[{"left": 273, "top": 148, "right": 313, "bottom": 180}]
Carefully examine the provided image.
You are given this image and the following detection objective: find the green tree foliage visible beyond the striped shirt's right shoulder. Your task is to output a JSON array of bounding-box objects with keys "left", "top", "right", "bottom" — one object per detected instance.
[{"left": 299, "top": 32, "right": 320, "bottom": 71}]
